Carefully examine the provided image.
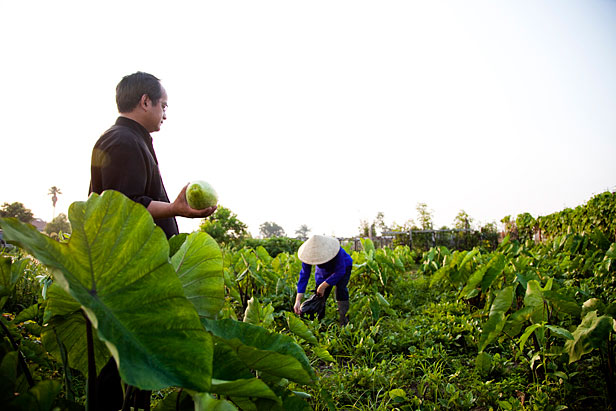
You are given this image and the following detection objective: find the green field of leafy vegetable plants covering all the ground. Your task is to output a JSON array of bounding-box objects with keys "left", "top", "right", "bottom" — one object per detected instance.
[{"left": 0, "top": 191, "right": 616, "bottom": 410}]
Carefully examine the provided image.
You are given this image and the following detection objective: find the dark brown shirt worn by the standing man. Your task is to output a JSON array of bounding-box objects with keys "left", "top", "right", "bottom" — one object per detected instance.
[{"left": 89, "top": 117, "right": 179, "bottom": 238}]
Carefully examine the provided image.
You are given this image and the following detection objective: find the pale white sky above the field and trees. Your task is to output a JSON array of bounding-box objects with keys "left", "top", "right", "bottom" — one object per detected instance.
[{"left": 0, "top": 0, "right": 616, "bottom": 237}]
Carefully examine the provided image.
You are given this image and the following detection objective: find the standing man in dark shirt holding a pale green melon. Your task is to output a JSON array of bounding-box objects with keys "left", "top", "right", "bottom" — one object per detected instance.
[{"left": 90, "top": 72, "right": 216, "bottom": 411}]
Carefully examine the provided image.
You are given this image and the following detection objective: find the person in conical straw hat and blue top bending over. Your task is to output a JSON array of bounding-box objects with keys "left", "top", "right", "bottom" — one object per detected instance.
[{"left": 293, "top": 235, "right": 353, "bottom": 325}]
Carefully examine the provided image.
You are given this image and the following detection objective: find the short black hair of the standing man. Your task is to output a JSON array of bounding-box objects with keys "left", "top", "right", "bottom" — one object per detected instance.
[{"left": 116, "top": 71, "right": 163, "bottom": 113}]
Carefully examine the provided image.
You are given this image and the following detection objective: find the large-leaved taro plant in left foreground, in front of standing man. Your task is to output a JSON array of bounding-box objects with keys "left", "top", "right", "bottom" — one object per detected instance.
[{"left": 0, "top": 191, "right": 315, "bottom": 407}]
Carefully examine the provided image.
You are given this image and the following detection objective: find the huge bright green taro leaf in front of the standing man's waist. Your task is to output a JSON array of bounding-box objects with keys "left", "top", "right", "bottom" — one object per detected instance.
[{"left": 0, "top": 191, "right": 213, "bottom": 392}]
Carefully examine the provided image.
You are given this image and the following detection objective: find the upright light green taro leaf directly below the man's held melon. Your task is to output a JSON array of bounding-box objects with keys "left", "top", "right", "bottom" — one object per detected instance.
[{"left": 171, "top": 233, "right": 225, "bottom": 318}]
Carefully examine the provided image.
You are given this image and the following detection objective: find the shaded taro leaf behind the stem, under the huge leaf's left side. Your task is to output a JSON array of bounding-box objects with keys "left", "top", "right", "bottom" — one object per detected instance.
[{"left": 42, "top": 284, "right": 111, "bottom": 375}]
